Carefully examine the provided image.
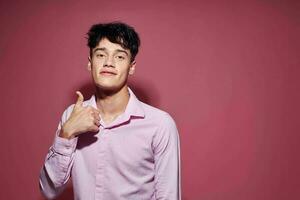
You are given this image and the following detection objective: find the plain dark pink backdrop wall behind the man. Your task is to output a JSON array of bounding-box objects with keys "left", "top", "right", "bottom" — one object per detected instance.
[{"left": 0, "top": 0, "right": 300, "bottom": 200}]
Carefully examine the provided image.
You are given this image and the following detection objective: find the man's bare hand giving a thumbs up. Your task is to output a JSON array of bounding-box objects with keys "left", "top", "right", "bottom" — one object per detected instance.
[{"left": 59, "top": 91, "right": 100, "bottom": 139}]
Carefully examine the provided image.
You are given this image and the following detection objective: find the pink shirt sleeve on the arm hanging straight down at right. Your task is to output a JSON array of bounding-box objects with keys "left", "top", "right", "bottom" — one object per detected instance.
[{"left": 153, "top": 115, "right": 181, "bottom": 200}]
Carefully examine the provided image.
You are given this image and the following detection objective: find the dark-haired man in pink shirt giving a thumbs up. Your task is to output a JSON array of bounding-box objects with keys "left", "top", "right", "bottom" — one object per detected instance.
[{"left": 40, "top": 23, "right": 180, "bottom": 200}]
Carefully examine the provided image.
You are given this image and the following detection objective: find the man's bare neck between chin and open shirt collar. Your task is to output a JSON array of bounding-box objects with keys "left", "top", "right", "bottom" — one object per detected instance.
[{"left": 96, "top": 85, "right": 129, "bottom": 123}]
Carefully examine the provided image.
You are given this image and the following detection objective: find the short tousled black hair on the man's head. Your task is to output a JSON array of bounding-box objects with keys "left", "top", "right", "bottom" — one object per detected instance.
[{"left": 87, "top": 22, "right": 140, "bottom": 61}]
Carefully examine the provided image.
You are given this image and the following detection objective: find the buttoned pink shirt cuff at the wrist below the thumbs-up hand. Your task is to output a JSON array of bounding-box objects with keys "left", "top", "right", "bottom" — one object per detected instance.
[{"left": 53, "top": 135, "right": 78, "bottom": 156}]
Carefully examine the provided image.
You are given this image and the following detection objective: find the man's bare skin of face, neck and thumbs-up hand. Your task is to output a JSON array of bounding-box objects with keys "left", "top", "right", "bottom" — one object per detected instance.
[{"left": 59, "top": 38, "right": 136, "bottom": 139}]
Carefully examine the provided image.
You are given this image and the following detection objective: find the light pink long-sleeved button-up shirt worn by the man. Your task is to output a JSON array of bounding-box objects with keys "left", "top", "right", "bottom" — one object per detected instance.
[{"left": 40, "top": 89, "right": 180, "bottom": 200}]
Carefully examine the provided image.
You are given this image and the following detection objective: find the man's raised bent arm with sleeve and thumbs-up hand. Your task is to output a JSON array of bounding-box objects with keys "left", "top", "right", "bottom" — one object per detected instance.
[{"left": 40, "top": 92, "right": 100, "bottom": 199}]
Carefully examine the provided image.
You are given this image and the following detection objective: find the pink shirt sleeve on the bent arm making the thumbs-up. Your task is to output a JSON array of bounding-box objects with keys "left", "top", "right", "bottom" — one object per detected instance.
[{"left": 39, "top": 107, "right": 77, "bottom": 199}]
